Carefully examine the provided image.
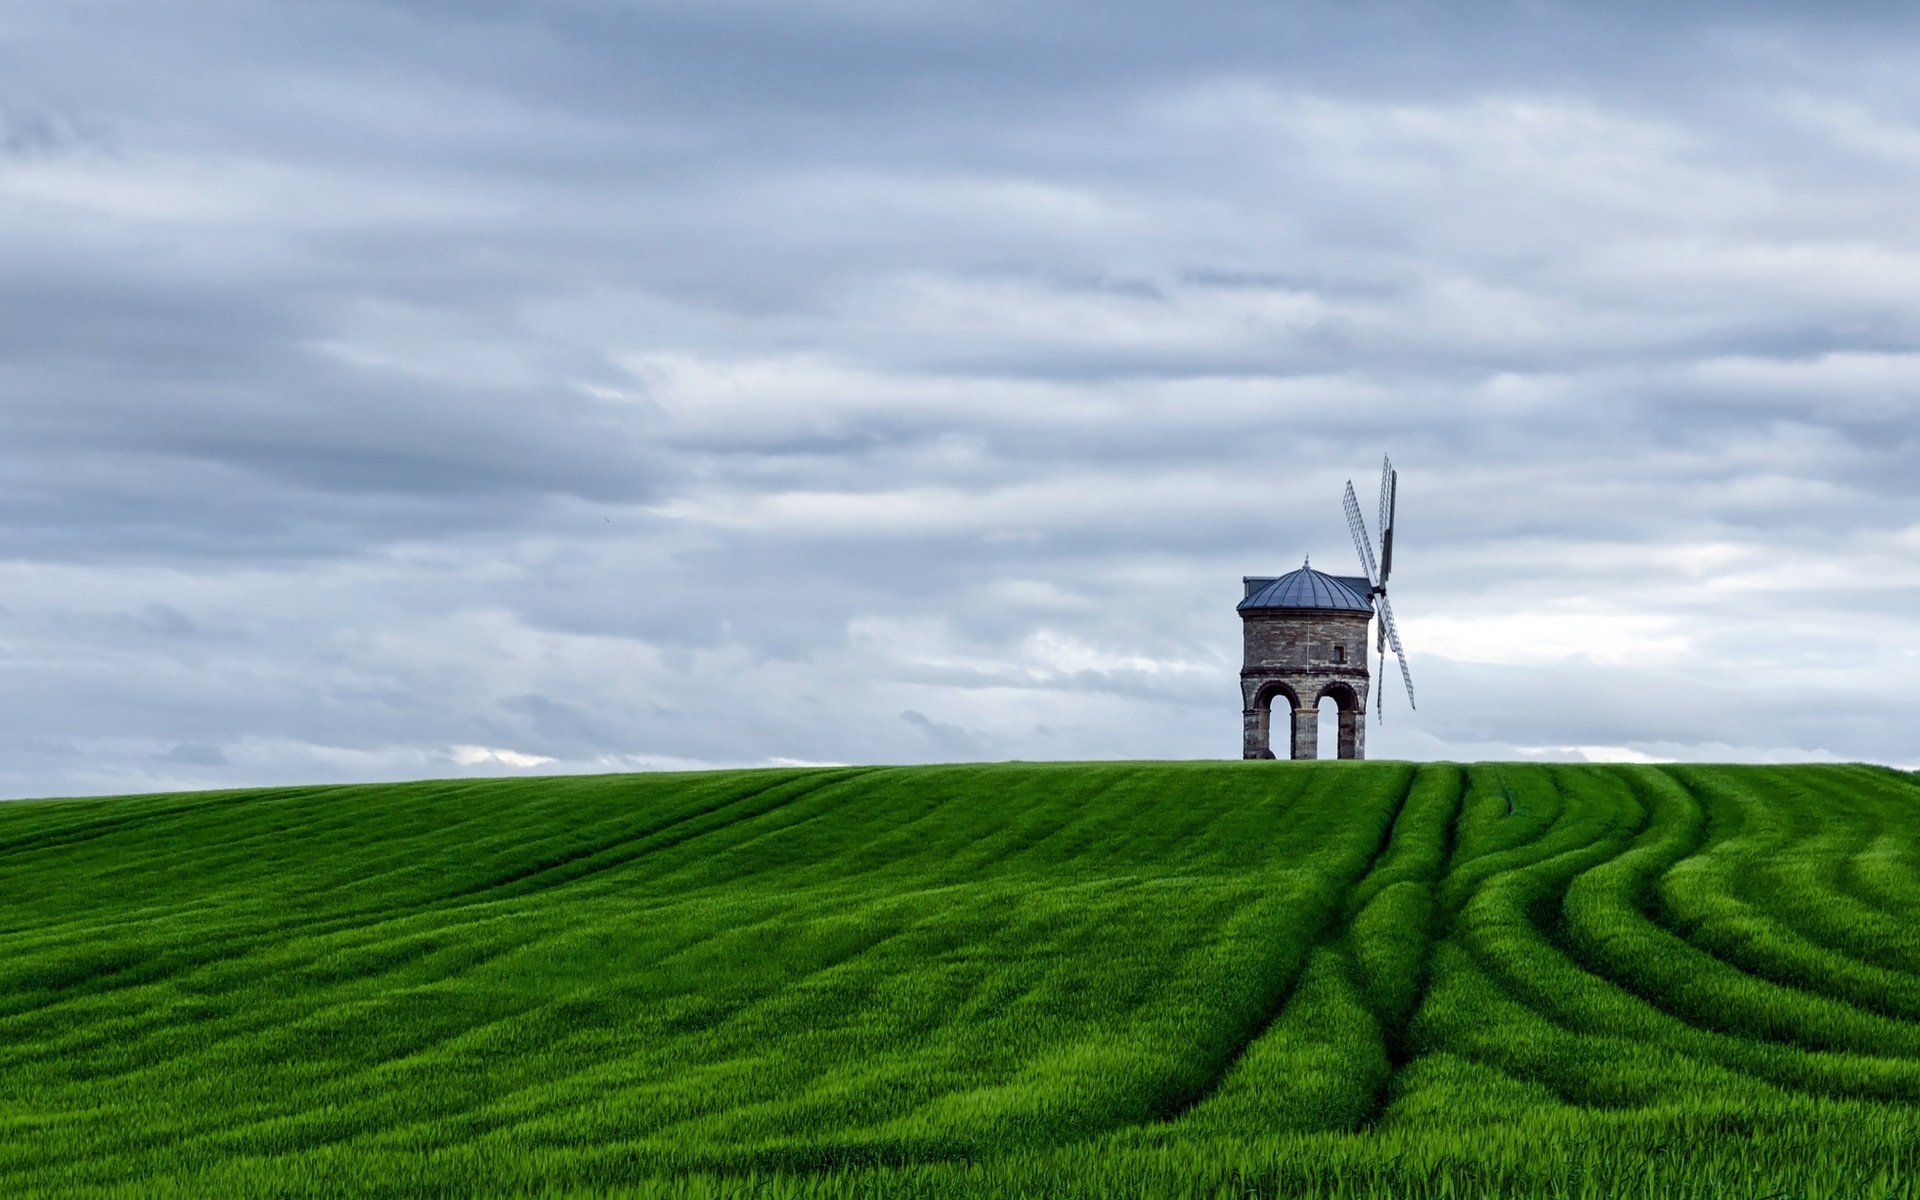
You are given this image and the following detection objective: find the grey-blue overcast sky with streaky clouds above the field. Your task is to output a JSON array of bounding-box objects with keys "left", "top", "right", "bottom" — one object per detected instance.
[{"left": 0, "top": 0, "right": 1920, "bottom": 797}]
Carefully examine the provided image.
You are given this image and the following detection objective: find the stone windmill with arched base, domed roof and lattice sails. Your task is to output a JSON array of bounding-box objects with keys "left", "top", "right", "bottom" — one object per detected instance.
[{"left": 1238, "top": 463, "right": 1413, "bottom": 758}]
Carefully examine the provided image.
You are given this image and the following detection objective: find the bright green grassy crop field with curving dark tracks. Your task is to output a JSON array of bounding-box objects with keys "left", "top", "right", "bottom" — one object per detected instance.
[{"left": 0, "top": 762, "right": 1920, "bottom": 1200}]
